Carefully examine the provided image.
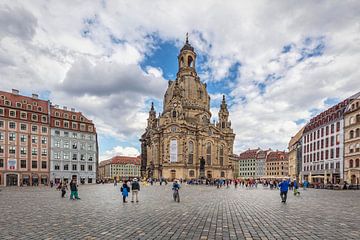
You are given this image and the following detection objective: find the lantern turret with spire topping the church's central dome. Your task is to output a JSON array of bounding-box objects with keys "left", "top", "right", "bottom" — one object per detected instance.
[{"left": 177, "top": 33, "right": 197, "bottom": 77}]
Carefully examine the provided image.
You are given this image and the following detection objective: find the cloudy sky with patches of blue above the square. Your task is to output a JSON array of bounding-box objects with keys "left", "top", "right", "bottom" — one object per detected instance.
[{"left": 0, "top": 0, "right": 360, "bottom": 160}]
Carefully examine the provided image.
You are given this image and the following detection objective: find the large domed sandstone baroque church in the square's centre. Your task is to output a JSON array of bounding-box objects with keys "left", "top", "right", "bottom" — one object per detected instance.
[{"left": 140, "top": 38, "right": 235, "bottom": 179}]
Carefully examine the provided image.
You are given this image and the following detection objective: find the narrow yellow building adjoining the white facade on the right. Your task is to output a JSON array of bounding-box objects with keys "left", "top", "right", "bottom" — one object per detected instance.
[{"left": 288, "top": 127, "right": 304, "bottom": 179}]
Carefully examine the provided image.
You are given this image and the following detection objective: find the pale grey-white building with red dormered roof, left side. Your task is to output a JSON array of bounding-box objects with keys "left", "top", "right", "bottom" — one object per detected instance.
[{"left": 50, "top": 107, "right": 98, "bottom": 183}]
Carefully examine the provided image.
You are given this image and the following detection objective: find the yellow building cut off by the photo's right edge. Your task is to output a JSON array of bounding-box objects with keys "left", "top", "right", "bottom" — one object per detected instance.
[{"left": 344, "top": 97, "right": 360, "bottom": 184}]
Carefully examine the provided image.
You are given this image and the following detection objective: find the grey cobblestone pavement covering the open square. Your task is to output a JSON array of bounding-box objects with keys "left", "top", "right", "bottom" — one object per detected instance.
[{"left": 0, "top": 184, "right": 360, "bottom": 239}]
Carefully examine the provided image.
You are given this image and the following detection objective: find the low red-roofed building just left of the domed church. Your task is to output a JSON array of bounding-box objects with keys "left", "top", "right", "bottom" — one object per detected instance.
[{"left": 99, "top": 156, "right": 141, "bottom": 180}]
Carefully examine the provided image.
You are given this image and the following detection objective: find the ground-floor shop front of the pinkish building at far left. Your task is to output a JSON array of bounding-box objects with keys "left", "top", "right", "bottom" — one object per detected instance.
[{"left": 0, "top": 172, "right": 49, "bottom": 187}]
